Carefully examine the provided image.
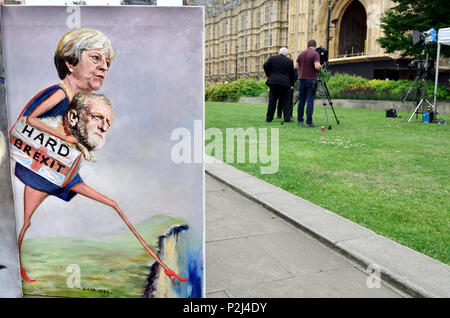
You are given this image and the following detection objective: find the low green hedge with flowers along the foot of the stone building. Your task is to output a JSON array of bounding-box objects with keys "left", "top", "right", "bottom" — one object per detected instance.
[{"left": 205, "top": 73, "right": 450, "bottom": 101}]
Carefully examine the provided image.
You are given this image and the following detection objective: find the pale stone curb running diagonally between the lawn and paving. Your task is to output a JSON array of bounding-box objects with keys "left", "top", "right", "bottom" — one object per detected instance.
[{"left": 205, "top": 156, "right": 450, "bottom": 298}]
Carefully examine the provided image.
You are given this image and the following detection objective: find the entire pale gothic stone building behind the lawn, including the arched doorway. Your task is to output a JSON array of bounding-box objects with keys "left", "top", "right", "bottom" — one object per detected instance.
[{"left": 189, "top": 0, "right": 448, "bottom": 85}]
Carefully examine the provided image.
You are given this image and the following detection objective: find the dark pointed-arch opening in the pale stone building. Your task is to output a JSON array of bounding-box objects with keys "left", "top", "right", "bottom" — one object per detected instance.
[{"left": 338, "top": 0, "right": 367, "bottom": 56}]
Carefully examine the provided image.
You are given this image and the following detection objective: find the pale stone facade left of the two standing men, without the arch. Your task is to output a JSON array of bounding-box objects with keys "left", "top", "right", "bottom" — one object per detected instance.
[{"left": 184, "top": 0, "right": 289, "bottom": 84}]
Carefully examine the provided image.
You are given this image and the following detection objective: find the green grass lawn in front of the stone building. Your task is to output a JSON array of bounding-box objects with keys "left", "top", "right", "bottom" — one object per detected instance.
[{"left": 205, "top": 101, "right": 450, "bottom": 264}]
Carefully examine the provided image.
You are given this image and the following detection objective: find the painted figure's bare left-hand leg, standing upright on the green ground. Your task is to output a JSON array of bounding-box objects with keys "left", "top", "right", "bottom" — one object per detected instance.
[{"left": 18, "top": 186, "right": 48, "bottom": 283}]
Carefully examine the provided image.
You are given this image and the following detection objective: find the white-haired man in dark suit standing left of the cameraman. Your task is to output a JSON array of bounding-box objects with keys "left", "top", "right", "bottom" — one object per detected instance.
[{"left": 264, "top": 47, "right": 297, "bottom": 122}]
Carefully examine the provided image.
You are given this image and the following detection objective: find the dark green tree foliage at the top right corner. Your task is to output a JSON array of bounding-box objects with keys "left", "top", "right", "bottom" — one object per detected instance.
[{"left": 377, "top": 0, "right": 450, "bottom": 59}]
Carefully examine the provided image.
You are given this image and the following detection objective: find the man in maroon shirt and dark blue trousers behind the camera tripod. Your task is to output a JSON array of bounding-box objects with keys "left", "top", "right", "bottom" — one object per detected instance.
[{"left": 294, "top": 40, "right": 323, "bottom": 128}]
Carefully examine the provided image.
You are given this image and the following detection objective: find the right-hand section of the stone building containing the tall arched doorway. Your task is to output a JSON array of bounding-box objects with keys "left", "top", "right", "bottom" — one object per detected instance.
[{"left": 289, "top": 0, "right": 409, "bottom": 79}]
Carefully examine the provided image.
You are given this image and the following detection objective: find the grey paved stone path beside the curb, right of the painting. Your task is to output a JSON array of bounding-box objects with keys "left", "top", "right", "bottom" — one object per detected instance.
[{"left": 206, "top": 175, "right": 405, "bottom": 298}]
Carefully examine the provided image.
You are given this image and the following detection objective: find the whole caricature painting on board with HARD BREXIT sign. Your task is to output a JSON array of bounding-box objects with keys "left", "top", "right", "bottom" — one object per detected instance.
[{"left": 2, "top": 6, "right": 204, "bottom": 298}]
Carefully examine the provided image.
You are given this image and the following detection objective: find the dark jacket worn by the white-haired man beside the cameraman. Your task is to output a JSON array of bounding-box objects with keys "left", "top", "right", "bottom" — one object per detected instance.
[{"left": 263, "top": 54, "right": 298, "bottom": 87}]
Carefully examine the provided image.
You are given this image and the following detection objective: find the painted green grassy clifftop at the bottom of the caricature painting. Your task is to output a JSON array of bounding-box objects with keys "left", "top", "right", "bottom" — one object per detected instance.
[{"left": 22, "top": 215, "right": 186, "bottom": 298}]
